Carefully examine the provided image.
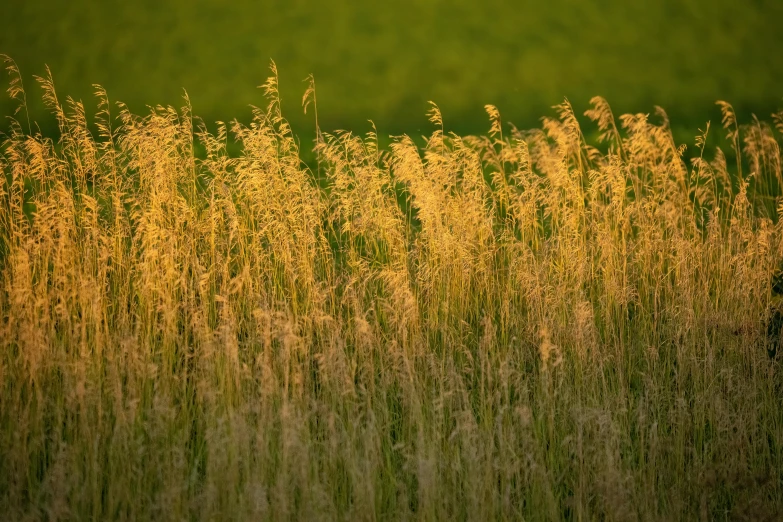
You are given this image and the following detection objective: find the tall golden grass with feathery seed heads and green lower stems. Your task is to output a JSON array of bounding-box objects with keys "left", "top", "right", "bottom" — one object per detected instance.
[{"left": 0, "top": 62, "right": 783, "bottom": 520}]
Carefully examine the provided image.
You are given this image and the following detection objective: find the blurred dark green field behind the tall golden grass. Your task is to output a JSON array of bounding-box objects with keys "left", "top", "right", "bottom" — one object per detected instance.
[{"left": 0, "top": 0, "right": 783, "bottom": 140}]
